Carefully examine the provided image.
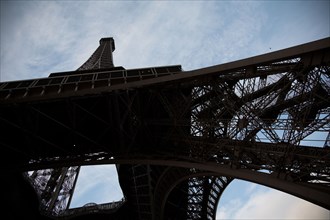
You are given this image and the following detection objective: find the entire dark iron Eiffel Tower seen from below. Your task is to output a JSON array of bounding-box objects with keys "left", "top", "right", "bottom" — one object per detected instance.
[{"left": 0, "top": 38, "right": 330, "bottom": 220}]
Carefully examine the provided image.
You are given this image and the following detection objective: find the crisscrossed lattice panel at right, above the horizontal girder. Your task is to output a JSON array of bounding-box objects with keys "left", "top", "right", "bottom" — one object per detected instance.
[{"left": 191, "top": 59, "right": 330, "bottom": 144}]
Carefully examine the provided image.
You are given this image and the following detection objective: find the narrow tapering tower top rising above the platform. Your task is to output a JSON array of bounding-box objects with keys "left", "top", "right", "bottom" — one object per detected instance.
[{"left": 77, "top": 37, "right": 115, "bottom": 70}]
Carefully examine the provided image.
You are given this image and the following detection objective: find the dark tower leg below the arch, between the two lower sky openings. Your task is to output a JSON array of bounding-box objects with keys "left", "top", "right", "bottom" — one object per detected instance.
[{"left": 119, "top": 163, "right": 232, "bottom": 219}]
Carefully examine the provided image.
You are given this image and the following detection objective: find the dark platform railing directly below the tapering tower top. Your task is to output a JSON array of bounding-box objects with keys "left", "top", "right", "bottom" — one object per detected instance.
[{"left": 0, "top": 65, "right": 181, "bottom": 102}]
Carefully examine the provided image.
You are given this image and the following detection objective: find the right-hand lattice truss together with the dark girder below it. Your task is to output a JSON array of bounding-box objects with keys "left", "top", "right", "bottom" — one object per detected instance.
[{"left": 186, "top": 58, "right": 330, "bottom": 186}]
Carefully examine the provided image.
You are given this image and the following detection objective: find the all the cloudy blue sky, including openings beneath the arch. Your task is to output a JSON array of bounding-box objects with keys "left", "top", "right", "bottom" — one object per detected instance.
[{"left": 0, "top": 0, "right": 330, "bottom": 219}]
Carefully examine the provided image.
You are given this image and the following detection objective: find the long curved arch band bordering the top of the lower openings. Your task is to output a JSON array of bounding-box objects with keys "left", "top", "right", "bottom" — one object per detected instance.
[{"left": 25, "top": 157, "right": 330, "bottom": 209}]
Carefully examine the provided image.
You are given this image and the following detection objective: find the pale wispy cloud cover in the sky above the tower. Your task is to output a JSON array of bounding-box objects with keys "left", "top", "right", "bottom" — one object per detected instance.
[{"left": 1, "top": 1, "right": 329, "bottom": 80}]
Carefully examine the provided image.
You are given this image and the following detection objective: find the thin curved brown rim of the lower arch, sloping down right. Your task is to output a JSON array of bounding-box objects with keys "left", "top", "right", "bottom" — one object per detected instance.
[{"left": 21, "top": 158, "right": 330, "bottom": 210}]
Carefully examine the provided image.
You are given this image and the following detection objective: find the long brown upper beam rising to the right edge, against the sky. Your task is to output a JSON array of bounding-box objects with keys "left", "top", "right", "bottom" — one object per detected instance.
[{"left": 0, "top": 38, "right": 330, "bottom": 104}]
